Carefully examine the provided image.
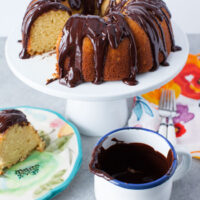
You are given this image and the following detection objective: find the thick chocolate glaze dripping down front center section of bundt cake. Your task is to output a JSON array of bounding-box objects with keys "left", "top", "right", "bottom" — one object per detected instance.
[{"left": 58, "top": 12, "right": 137, "bottom": 87}]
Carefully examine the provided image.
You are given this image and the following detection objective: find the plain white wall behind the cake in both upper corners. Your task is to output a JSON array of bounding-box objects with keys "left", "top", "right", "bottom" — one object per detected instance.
[{"left": 0, "top": 0, "right": 200, "bottom": 37}]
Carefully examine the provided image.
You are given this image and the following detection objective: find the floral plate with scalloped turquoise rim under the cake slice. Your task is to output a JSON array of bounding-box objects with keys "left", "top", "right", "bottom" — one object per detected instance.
[{"left": 0, "top": 106, "right": 82, "bottom": 200}]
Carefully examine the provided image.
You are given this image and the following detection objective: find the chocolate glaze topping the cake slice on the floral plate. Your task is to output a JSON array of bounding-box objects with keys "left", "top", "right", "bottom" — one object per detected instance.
[{"left": 0, "top": 110, "right": 28, "bottom": 133}]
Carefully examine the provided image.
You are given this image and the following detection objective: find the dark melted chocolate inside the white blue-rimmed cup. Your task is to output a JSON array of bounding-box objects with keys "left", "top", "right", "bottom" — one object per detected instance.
[{"left": 89, "top": 138, "right": 173, "bottom": 184}]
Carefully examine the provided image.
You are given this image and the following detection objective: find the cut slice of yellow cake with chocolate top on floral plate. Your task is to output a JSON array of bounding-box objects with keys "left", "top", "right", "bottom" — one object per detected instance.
[{"left": 0, "top": 110, "right": 45, "bottom": 174}]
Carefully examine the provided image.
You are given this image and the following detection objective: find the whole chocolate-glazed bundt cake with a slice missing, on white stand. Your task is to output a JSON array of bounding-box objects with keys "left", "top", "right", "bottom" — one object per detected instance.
[{"left": 21, "top": 0, "right": 181, "bottom": 87}]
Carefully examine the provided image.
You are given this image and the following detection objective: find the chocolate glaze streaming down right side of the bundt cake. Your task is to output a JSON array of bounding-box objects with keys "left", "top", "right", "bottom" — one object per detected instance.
[{"left": 122, "top": 0, "right": 181, "bottom": 71}]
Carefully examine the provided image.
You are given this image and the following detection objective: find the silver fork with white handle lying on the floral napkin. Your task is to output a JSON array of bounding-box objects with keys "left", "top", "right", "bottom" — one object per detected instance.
[{"left": 158, "top": 89, "right": 176, "bottom": 145}]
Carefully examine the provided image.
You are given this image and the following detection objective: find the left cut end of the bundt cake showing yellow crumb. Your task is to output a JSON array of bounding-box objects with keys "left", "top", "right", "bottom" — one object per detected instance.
[{"left": 20, "top": 0, "right": 71, "bottom": 59}]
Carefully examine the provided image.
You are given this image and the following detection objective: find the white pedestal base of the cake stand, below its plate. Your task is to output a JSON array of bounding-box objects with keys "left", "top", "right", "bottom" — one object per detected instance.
[{"left": 66, "top": 98, "right": 132, "bottom": 136}]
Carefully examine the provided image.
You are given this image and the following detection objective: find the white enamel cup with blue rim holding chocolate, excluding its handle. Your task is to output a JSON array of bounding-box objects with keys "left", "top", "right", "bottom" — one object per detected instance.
[{"left": 89, "top": 128, "right": 190, "bottom": 200}]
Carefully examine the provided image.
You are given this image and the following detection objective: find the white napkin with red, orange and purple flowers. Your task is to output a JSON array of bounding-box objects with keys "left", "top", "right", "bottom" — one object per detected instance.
[{"left": 128, "top": 55, "right": 200, "bottom": 159}]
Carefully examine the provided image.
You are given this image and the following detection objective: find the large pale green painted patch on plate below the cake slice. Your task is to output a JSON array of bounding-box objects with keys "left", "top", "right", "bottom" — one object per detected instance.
[{"left": 0, "top": 151, "right": 58, "bottom": 195}]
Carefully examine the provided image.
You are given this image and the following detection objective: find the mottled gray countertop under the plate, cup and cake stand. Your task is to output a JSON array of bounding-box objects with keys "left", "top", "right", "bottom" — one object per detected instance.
[{"left": 0, "top": 35, "right": 200, "bottom": 200}]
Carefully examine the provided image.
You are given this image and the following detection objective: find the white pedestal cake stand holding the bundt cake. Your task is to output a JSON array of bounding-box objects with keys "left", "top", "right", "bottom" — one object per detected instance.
[{"left": 5, "top": 24, "right": 189, "bottom": 136}]
